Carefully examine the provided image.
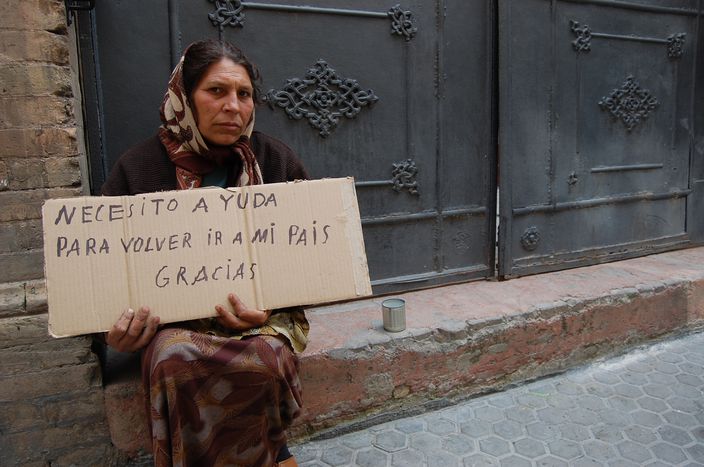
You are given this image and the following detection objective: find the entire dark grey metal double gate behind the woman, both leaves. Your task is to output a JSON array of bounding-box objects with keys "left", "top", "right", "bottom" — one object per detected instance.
[{"left": 74, "top": 0, "right": 704, "bottom": 293}]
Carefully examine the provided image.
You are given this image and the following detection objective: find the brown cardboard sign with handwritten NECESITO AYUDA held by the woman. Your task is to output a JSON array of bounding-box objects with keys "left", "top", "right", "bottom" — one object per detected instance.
[{"left": 43, "top": 178, "right": 371, "bottom": 337}]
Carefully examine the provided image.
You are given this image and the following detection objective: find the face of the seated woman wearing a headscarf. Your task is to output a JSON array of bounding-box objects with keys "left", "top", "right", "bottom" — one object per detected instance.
[{"left": 191, "top": 58, "right": 254, "bottom": 146}]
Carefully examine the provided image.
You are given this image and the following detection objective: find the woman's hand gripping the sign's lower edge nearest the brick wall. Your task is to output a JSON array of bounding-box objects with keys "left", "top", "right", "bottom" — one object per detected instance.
[{"left": 105, "top": 306, "right": 159, "bottom": 352}]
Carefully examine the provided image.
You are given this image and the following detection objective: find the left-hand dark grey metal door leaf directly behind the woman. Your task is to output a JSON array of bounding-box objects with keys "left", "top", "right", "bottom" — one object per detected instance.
[{"left": 80, "top": 0, "right": 496, "bottom": 292}]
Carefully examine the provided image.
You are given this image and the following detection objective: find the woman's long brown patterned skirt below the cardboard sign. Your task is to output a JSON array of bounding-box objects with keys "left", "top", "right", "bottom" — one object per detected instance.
[{"left": 142, "top": 328, "right": 301, "bottom": 467}]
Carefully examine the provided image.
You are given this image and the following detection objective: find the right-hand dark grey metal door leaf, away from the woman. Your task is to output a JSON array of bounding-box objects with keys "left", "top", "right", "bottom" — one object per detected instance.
[{"left": 499, "top": 0, "right": 704, "bottom": 276}]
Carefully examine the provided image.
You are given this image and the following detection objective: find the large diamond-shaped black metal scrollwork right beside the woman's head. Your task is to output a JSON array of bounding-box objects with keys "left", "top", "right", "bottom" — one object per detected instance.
[{"left": 264, "top": 60, "right": 379, "bottom": 138}]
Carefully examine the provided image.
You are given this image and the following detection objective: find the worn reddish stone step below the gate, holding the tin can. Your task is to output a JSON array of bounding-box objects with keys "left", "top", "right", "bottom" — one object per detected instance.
[{"left": 105, "top": 248, "right": 704, "bottom": 456}]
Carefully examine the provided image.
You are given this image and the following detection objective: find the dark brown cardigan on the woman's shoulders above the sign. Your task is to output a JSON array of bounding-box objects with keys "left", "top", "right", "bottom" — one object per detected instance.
[{"left": 101, "top": 131, "right": 309, "bottom": 196}]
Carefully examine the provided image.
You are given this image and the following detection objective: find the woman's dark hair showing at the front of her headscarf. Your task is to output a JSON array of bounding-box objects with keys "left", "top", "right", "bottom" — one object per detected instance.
[{"left": 182, "top": 39, "right": 261, "bottom": 102}]
